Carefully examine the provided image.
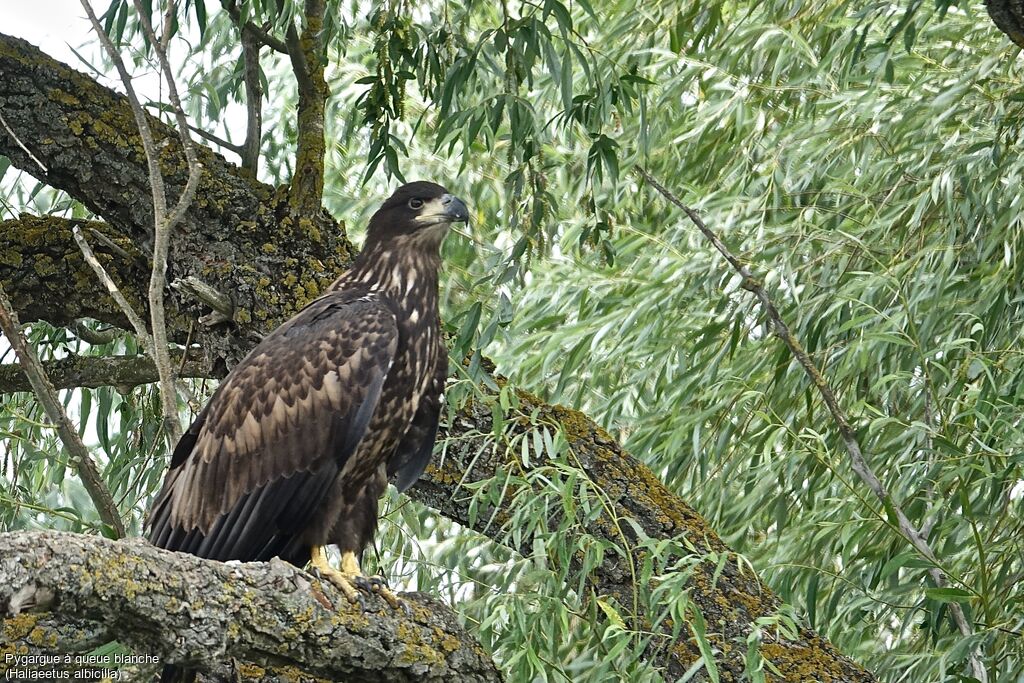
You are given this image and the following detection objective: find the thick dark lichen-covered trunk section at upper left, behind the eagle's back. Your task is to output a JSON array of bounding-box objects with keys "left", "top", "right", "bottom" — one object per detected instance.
[{"left": 0, "top": 34, "right": 351, "bottom": 366}]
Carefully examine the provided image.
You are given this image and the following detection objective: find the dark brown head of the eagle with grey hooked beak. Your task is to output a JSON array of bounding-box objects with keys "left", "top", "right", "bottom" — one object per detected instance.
[{"left": 367, "top": 181, "right": 469, "bottom": 249}]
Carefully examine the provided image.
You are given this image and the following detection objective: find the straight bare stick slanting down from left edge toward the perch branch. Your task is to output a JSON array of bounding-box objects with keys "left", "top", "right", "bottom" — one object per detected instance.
[{"left": 0, "top": 286, "right": 125, "bottom": 537}]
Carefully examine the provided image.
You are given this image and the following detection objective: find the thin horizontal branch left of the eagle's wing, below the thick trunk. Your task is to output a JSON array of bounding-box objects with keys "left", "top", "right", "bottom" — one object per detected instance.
[{"left": 0, "top": 352, "right": 216, "bottom": 394}]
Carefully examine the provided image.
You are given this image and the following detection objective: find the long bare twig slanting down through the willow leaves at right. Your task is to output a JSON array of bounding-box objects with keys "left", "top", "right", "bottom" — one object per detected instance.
[{"left": 636, "top": 166, "right": 988, "bottom": 683}]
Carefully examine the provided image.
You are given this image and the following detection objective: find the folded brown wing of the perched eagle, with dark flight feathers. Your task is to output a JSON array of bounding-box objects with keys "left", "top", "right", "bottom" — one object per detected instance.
[{"left": 148, "top": 292, "right": 397, "bottom": 561}]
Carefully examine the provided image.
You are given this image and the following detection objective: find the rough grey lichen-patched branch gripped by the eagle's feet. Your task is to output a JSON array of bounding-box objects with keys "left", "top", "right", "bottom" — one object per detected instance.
[{"left": 0, "top": 531, "right": 501, "bottom": 683}]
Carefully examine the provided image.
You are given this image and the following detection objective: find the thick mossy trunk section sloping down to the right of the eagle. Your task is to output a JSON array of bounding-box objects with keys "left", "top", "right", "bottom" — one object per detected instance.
[{"left": 409, "top": 392, "right": 874, "bottom": 683}]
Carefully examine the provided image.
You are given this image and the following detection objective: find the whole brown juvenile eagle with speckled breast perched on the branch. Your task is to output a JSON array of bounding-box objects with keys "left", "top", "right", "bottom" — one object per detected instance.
[{"left": 148, "top": 182, "right": 468, "bottom": 600}]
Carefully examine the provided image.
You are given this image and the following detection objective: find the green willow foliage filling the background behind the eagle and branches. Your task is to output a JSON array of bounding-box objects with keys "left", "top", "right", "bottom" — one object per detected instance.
[{"left": 0, "top": 0, "right": 1024, "bottom": 683}]
